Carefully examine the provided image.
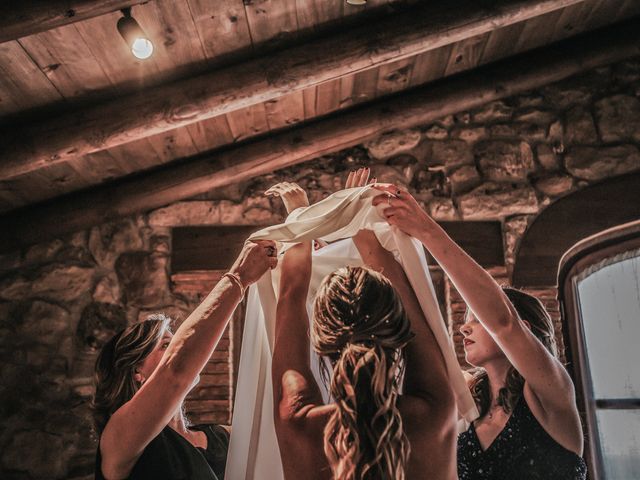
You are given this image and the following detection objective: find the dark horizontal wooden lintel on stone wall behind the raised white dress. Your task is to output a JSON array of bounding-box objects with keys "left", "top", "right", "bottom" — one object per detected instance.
[{"left": 171, "top": 221, "right": 504, "bottom": 274}]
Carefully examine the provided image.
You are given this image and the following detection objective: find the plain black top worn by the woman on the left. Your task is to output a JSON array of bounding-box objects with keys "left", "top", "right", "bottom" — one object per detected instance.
[{"left": 95, "top": 425, "right": 229, "bottom": 480}]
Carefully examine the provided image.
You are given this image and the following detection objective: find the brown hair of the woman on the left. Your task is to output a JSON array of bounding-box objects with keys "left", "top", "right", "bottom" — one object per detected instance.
[{"left": 91, "top": 314, "right": 171, "bottom": 436}]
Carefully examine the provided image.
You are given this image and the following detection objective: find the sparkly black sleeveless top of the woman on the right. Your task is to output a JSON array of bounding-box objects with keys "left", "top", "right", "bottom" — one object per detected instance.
[{"left": 458, "top": 396, "right": 587, "bottom": 480}]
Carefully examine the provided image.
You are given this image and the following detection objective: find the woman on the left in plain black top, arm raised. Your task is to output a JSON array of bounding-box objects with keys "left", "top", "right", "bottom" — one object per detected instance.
[{"left": 92, "top": 241, "right": 277, "bottom": 480}]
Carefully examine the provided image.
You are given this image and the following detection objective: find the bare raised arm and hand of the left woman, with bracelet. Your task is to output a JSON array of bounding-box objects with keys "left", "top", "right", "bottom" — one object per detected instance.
[{"left": 100, "top": 241, "right": 277, "bottom": 478}]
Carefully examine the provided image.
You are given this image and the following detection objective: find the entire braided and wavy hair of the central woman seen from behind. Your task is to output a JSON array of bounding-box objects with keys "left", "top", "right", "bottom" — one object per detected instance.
[{"left": 311, "top": 267, "right": 413, "bottom": 480}]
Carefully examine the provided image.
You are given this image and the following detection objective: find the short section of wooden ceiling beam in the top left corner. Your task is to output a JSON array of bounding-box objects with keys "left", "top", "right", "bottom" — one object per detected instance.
[{"left": 0, "top": 0, "right": 149, "bottom": 43}]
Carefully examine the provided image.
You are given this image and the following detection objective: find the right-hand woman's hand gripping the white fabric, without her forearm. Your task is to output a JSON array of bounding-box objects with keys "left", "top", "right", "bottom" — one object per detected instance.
[{"left": 373, "top": 183, "right": 435, "bottom": 238}]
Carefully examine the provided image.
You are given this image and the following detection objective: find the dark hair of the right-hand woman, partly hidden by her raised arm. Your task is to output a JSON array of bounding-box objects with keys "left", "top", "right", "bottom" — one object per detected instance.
[{"left": 469, "top": 287, "right": 558, "bottom": 417}]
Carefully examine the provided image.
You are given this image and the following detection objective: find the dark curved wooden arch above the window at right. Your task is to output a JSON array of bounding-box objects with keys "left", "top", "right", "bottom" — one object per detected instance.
[{"left": 513, "top": 173, "right": 640, "bottom": 287}]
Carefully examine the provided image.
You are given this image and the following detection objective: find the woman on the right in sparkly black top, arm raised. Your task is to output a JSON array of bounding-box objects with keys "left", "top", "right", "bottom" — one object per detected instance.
[{"left": 373, "top": 185, "right": 586, "bottom": 480}]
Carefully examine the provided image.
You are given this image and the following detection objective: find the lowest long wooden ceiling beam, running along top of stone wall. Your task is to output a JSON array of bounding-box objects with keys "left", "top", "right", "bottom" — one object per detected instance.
[{"left": 0, "top": 19, "right": 640, "bottom": 251}]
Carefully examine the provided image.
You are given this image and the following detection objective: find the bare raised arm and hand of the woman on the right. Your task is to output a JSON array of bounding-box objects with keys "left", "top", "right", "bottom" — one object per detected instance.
[{"left": 374, "top": 185, "right": 577, "bottom": 436}]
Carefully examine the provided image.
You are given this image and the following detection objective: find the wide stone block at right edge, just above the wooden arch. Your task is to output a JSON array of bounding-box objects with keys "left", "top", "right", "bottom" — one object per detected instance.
[{"left": 565, "top": 145, "right": 640, "bottom": 181}]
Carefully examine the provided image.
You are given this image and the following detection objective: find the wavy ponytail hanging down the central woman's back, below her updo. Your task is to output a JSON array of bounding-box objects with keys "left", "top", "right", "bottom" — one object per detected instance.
[{"left": 324, "top": 343, "right": 410, "bottom": 480}]
